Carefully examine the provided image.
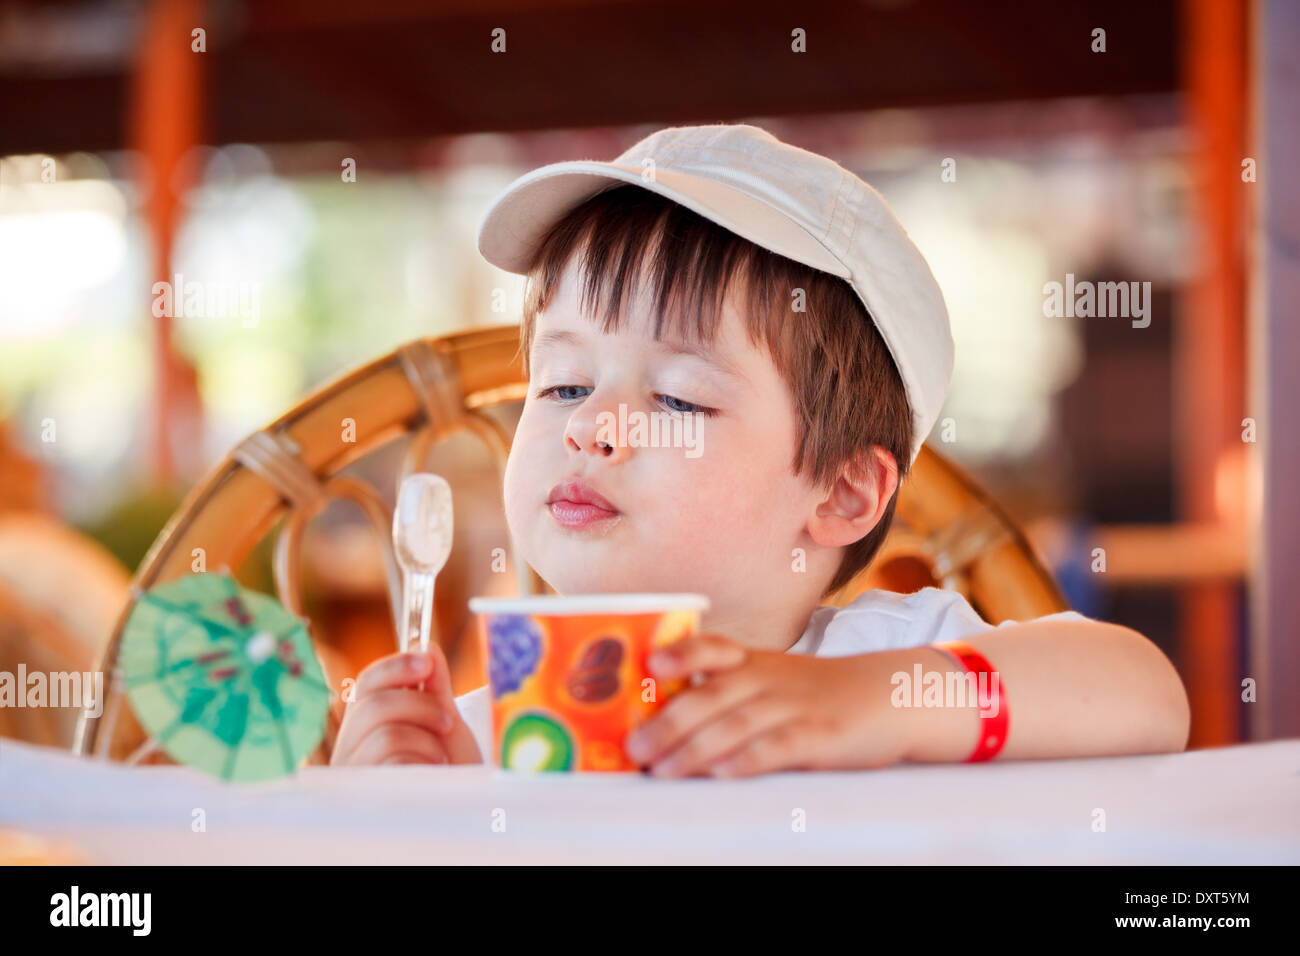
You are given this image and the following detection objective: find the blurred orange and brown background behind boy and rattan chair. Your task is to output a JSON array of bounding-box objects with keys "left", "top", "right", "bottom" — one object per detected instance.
[{"left": 0, "top": 0, "right": 1300, "bottom": 747}]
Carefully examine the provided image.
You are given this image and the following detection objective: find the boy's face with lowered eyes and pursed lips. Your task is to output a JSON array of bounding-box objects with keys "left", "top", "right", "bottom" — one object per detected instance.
[{"left": 504, "top": 265, "right": 819, "bottom": 618}]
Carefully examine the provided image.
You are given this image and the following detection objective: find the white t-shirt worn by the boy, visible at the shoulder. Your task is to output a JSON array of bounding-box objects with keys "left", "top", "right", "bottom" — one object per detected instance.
[{"left": 456, "top": 588, "right": 1088, "bottom": 760}]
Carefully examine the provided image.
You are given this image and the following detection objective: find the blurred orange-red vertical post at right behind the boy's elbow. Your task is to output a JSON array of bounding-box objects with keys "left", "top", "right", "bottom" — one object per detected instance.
[{"left": 1174, "top": 0, "right": 1248, "bottom": 747}]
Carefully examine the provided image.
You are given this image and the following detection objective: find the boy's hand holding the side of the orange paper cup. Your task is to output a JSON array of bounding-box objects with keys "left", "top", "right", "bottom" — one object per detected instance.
[{"left": 627, "top": 635, "right": 909, "bottom": 777}]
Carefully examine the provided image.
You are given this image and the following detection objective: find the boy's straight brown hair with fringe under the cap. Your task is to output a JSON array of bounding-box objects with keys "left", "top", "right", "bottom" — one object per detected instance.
[{"left": 520, "top": 185, "right": 913, "bottom": 596}]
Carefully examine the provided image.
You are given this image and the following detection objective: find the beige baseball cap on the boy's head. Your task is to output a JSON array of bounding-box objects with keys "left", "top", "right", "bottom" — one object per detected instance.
[{"left": 478, "top": 124, "right": 953, "bottom": 462}]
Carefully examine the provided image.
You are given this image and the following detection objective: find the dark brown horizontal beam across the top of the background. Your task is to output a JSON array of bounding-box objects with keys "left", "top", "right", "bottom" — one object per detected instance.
[{"left": 0, "top": 0, "right": 1179, "bottom": 153}]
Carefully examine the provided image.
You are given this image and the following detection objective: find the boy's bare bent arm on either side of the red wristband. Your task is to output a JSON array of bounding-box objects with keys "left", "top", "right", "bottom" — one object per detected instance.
[{"left": 889, "top": 620, "right": 1191, "bottom": 762}]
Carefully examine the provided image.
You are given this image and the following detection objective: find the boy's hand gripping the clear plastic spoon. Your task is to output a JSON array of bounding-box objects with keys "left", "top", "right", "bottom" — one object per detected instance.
[{"left": 329, "top": 646, "right": 482, "bottom": 766}]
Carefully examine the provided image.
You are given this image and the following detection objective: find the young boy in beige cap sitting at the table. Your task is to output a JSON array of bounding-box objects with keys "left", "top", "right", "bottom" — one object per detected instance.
[{"left": 333, "top": 125, "right": 1190, "bottom": 777}]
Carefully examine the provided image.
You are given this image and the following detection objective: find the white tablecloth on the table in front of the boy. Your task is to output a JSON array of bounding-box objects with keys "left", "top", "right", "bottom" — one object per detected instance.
[{"left": 0, "top": 740, "right": 1300, "bottom": 864}]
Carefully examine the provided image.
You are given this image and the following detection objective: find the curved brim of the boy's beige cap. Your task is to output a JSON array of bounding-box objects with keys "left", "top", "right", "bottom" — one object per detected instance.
[{"left": 478, "top": 161, "right": 850, "bottom": 278}]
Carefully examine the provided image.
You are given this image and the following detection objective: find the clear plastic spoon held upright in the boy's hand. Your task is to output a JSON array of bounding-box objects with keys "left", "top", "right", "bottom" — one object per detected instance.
[{"left": 393, "top": 472, "right": 452, "bottom": 691}]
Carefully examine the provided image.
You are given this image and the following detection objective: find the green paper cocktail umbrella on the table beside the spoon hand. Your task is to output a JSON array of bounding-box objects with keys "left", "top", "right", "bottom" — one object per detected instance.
[{"left": 118, "top": 571, "right": 330, "bottom": 780}]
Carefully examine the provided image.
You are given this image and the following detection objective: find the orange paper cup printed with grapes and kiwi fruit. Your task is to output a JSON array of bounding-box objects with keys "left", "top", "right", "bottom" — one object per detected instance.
[{"left": 469, "top": 594, "right": 709, "bottom": 773}]
